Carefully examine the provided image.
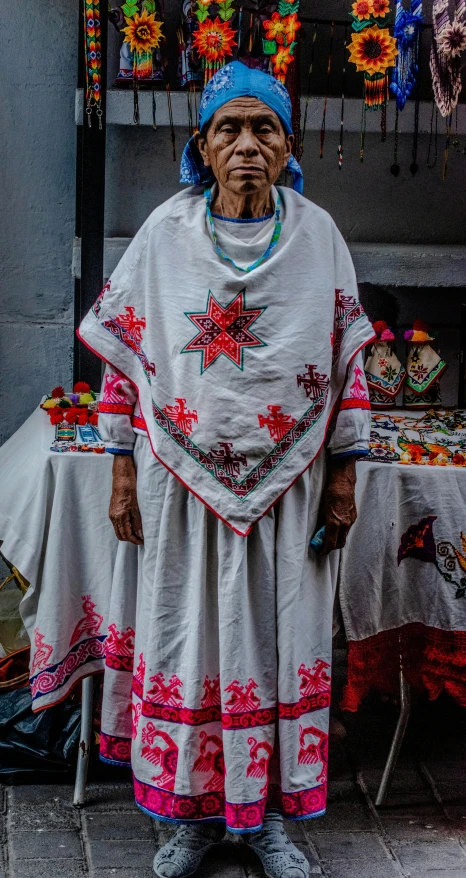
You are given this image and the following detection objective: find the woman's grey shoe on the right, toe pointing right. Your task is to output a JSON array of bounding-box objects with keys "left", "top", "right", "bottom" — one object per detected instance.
[{"left": 246, "top": 814, "right": 310, "bottom": 878}]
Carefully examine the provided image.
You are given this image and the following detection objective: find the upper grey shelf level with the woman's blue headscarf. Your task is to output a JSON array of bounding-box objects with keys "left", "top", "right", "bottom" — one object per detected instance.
[{"left": 75, "top": 88, "right": 466, "bottom": 134}]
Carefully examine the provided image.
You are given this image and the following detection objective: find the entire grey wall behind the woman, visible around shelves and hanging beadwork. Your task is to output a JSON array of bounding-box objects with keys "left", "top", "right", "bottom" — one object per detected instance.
[{"left": 0, "top": 0, "right": 466, "bottom": 441}]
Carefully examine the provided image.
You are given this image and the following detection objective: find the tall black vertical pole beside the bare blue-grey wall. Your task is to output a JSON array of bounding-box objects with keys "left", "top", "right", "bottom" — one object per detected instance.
[{"left": 73, "top": 0, "right": 108, "bottom": 390}]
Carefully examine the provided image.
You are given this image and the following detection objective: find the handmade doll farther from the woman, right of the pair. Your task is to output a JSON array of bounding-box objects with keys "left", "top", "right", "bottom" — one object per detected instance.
[{"left": 403, "top": 320, "right": 447, "bottom": 409}]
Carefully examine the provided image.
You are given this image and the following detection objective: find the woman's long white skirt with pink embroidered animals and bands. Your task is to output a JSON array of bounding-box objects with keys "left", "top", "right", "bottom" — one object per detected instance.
[{"left": 101, "top": 436, "right": 338, "bottom": 832}]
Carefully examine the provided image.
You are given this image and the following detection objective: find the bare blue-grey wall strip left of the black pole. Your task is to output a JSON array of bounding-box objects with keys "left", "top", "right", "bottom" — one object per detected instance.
[{"left": 0, "top": 0, "right": 78, "bottom": 441}]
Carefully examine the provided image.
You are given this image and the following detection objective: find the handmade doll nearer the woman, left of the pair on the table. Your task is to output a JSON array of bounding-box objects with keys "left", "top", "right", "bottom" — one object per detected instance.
[{"left": 365, "top": 320, "right": 406, "bottom": 409}]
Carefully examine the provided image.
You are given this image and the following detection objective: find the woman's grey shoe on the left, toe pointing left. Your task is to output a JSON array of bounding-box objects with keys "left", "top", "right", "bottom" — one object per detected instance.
[{"left": 154, "top": 823, "right": 225, "bottom": 878}]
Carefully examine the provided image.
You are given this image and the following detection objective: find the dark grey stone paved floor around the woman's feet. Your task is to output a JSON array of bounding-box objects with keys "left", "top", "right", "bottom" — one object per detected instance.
[{"left": 0, "top": 699, "right": 466, "bottom": 878}]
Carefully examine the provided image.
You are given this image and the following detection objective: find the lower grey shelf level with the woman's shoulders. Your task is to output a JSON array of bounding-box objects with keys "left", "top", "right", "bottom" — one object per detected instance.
[{"left": 72, "top": 238, "right": 466, "bottom": 290}]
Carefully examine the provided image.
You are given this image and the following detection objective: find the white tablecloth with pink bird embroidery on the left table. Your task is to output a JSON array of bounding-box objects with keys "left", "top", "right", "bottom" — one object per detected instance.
[{"left": 0, "top": 408, "right": 122, "bottom": 710}]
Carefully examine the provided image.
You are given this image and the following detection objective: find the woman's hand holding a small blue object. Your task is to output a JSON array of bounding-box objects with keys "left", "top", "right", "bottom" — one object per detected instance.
[{"left": 322, "top": 455, "right": 357, "bottom": 555}]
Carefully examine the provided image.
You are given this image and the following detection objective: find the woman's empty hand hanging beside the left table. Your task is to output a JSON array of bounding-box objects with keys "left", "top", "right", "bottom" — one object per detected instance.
[{"left": 108, "top": 454, "right": 144, "bottom": 546}]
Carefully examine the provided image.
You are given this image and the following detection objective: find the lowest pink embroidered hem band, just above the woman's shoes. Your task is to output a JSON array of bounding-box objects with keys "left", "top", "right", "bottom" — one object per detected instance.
[{"left": 134, "top": 777, "right": 327, "bottom": 832}]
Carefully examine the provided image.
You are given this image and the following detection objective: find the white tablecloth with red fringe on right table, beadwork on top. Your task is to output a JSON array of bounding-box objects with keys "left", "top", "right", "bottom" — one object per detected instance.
[{"left": 340, "top": 411, "right": 466, "bottom": 710}]
